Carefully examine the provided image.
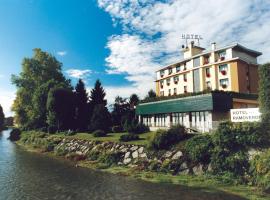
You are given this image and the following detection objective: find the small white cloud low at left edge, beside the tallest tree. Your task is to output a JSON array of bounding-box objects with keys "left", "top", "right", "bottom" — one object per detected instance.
[{"left": 0, "top": 88, "right": 15, "bottom": 117}]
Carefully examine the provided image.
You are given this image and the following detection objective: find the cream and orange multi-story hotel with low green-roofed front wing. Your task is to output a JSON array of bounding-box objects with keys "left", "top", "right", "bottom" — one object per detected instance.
[{"left": 136, "top": 42, "right": 262, "bottom": 131}]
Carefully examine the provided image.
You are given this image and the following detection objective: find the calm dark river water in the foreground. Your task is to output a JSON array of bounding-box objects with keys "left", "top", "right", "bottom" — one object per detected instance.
[{"left": 0, "top": 131, "right": 247, "bottom": 200}]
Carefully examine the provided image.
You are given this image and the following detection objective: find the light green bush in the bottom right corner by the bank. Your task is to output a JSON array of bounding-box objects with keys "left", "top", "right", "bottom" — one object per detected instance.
[{"left": 250, "top": 149, "right": 270, "bottom": 191}]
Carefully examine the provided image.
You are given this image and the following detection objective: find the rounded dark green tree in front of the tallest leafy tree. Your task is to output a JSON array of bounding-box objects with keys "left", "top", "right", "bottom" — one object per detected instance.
[{"left": 47, "top": 88, "right": 75, "bottom": 131}]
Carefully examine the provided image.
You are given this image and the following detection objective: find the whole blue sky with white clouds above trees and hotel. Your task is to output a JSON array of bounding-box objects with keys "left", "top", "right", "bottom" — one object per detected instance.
[{"left": 0, "top": 0, "right": 270, "bottom": 116}]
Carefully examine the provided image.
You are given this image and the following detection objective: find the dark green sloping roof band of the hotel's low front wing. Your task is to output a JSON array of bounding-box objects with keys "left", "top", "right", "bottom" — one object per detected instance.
[{"left": 136, "top": 93, "right": 232, "bottom": 115}]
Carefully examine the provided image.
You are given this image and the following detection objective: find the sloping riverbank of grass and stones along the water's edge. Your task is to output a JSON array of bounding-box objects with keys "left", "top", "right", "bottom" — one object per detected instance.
[{"left": 17, "top": 133, "right": 270, "bottom": 199}]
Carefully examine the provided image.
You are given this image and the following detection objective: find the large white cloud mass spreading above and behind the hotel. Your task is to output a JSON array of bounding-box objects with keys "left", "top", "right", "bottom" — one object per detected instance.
[{"left": 98, "top": 0, "right": 270, "bottom": 96}]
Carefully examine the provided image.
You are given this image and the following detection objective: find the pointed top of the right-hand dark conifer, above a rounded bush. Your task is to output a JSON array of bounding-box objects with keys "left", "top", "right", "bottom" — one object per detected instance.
[{"left": 90, "top": 80, "right": 107, "bottom": 107}]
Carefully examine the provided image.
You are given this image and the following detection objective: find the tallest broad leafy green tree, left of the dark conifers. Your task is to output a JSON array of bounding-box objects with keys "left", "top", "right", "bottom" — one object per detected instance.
[{"left": 12, "top": 49, "right": 71, "bottom": 129}]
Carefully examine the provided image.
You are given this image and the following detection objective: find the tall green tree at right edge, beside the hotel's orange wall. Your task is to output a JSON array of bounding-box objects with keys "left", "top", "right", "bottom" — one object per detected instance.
[{"left": 259, "top": 63, "right": 270, "bottom": 130}]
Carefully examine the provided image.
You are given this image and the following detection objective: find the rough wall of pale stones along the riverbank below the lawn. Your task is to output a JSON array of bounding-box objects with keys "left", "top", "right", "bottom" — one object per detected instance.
[{"left": 53, "top": 139, "right": 209, "bottom": 175}]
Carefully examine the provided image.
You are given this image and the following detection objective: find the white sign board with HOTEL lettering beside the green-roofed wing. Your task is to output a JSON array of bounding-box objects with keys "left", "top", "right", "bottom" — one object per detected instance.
[{"left": 231, "top": 108, "right": 261, "bottom": 122}]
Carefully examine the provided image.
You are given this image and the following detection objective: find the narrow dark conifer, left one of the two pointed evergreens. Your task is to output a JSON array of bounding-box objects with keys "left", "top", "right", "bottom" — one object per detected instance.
[{"left": 75, "top": 79, "right": 91, "bottom": 131}]
